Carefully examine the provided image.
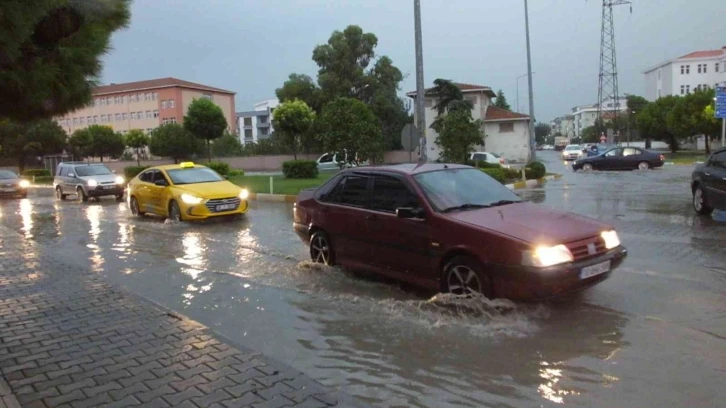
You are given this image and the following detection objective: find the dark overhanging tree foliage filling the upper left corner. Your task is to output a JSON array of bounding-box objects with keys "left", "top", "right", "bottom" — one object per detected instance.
[{"left": 0, "top": 0, "right": 131, "bottom": 122}]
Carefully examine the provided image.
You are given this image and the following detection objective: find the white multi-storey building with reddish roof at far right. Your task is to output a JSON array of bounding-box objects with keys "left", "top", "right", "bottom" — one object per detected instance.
[{"left": 643, "top": 47, "right": 726, "bottom": 101}]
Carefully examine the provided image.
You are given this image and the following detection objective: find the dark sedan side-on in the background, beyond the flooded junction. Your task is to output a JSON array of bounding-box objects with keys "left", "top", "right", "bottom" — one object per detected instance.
[{"left": 572, "top": 147, "right": 665, "bottom": 171}]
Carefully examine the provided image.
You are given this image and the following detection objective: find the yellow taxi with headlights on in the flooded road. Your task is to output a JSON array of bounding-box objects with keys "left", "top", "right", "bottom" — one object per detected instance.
[{"left": 126, "top": 162, "right": 249, "bottom": 221}]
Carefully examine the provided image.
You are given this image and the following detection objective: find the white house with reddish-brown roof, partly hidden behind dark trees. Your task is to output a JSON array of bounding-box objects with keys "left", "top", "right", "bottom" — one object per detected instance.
[{"left": 406, "top": 83, "right": 530, "bottom": 162}]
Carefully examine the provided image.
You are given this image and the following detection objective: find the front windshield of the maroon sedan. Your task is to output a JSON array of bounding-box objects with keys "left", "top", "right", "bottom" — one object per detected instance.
[{"left": 414, "top": 168, "right": 522, "bottom": 212}]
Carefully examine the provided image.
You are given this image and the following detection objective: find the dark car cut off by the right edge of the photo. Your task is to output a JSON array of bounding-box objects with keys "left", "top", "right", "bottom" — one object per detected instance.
[{"left": 691, "top": 148, "right": 726, "bottom": 215}]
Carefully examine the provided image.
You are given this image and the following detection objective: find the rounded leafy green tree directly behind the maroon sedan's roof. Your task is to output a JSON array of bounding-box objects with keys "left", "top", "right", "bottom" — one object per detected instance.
[{"left": 319, "top": 98, "right": 385, "bottom": 164}]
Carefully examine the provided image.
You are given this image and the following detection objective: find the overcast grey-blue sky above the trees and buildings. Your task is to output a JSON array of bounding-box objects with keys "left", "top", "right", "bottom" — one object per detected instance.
[{"left": 103, "top": 0, "right": 726, "bottom": 121}]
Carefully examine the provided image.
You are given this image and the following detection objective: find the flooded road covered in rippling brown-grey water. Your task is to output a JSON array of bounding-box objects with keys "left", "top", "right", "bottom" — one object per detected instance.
[{"left": 0, "top": 152, "right": 726, "bottom": 407}]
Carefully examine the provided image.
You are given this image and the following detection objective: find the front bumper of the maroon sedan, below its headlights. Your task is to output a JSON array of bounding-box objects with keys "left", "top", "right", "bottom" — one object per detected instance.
[{"left": 494, "top": 246, "right": 628, "bottom": 301}]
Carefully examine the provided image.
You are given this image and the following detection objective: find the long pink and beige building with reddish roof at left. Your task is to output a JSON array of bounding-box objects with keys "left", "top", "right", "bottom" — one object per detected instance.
[{"left": 56, "top": 78, "right": 236, "bottom": 134}]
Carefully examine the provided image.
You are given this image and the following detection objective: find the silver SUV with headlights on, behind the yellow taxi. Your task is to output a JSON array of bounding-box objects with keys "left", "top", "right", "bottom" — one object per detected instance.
[{"left": 53, "top": 162, "right": 125, "bottom": 202}]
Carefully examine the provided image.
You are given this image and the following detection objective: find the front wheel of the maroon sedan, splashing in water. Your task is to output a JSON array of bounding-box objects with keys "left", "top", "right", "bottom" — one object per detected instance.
[{"left": 443, "top": 256, "right": 493, "bottom": 298}]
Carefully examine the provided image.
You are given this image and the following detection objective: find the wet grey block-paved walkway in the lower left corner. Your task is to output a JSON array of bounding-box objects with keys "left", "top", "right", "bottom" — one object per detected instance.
[{"left": 0, "top": 227, "right": 361, "bottom": 408}]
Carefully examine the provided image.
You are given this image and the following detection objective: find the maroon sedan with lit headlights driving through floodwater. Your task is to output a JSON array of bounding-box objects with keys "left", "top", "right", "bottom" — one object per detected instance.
[{"left": 294, "top": 164, "right": 627, "bottom": 300}]
